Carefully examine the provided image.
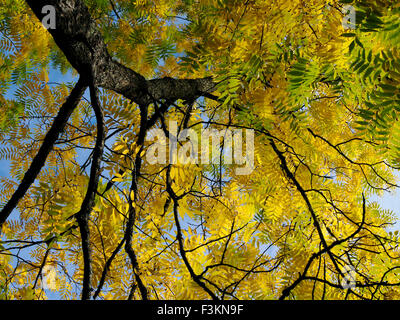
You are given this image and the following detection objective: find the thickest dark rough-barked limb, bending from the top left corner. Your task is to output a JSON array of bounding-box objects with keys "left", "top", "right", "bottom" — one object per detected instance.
[{"left": 26, "top": 0, "right": 214, "bottom": 105}]
